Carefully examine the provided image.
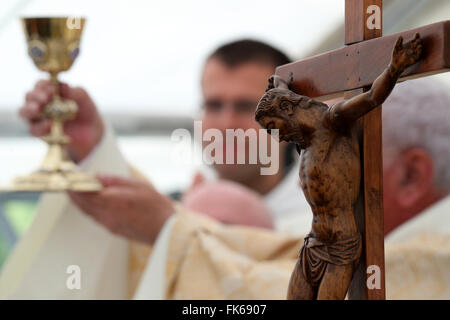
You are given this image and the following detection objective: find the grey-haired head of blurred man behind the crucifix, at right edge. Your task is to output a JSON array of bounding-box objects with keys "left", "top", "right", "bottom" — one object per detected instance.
[{"left": 383, "top": 78, "right": 450, "bottom": 233}]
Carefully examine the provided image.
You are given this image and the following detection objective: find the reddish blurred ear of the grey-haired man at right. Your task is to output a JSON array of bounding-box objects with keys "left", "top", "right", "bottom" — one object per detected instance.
[{"left": 397, "top": 148, "right": 434, "bottom": 208}]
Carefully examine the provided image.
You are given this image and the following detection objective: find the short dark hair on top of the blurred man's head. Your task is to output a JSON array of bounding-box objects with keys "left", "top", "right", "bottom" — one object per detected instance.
[{"left": 208, "top": 39, "right": 291, "bottom": 68}]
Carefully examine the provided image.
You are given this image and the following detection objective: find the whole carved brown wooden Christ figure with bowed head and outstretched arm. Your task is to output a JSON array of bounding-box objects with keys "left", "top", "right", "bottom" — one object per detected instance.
[{"left": 255, "top": 34, "right": 422, "bottom": 299}]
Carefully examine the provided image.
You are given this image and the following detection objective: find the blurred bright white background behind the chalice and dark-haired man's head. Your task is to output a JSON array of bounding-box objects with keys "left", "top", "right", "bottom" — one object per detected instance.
[{"left": 0, "top": 0, "right": 344, "bottom": 114}]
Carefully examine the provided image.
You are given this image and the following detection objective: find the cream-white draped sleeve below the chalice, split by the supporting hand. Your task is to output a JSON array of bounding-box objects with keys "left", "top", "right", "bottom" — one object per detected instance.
[{"left": 0, "top": 125, "right": 130, "bottom": 299}]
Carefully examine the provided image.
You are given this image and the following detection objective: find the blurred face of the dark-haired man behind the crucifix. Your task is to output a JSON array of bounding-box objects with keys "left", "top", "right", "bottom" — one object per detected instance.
[{"left": 202, "top": 58, "right": 274, "bottom": 182}]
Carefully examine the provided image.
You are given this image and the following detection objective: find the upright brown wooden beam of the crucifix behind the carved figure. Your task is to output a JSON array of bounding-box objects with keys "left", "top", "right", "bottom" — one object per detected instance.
[{"left": 344, "top": 0, "right": 385, "bottom": 300}]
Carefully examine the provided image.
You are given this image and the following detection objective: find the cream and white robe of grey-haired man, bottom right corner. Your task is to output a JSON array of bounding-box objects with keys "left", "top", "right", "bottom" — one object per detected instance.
[{"left": 386, "top": 196, "right": 450, "bottom": 300}]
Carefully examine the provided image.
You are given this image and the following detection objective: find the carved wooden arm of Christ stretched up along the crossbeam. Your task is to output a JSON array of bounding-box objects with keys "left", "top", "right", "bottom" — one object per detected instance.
[{"left": 330, "top": 33, "right": 422, "bottom": 125}]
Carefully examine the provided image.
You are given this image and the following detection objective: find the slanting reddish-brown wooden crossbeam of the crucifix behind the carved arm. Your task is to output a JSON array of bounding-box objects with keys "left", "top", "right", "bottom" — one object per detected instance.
[{"left": 276, "top": 20, "right": 450, "bottom": 100}]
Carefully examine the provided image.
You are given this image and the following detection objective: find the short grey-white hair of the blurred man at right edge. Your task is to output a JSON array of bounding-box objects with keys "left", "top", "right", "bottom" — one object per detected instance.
[{"left": 383, "top": 78, "right": 450, "bottom": 192}]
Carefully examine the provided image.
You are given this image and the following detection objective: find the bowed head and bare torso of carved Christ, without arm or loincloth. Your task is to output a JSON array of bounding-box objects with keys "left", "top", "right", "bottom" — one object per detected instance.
[{"left": 255, "top": 88, "right": 361, "bottom": 243}]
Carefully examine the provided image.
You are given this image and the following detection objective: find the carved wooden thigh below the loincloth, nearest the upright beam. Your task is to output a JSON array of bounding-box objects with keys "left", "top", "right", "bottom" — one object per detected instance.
[{"left": 317, "top": 263, "right": 354, "bottom": 300}]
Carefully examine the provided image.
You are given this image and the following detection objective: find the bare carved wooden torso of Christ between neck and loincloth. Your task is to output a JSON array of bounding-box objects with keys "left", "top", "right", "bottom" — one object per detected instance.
[{"left": 299, "top": 114, "right": 361, "bottom": 243}]
